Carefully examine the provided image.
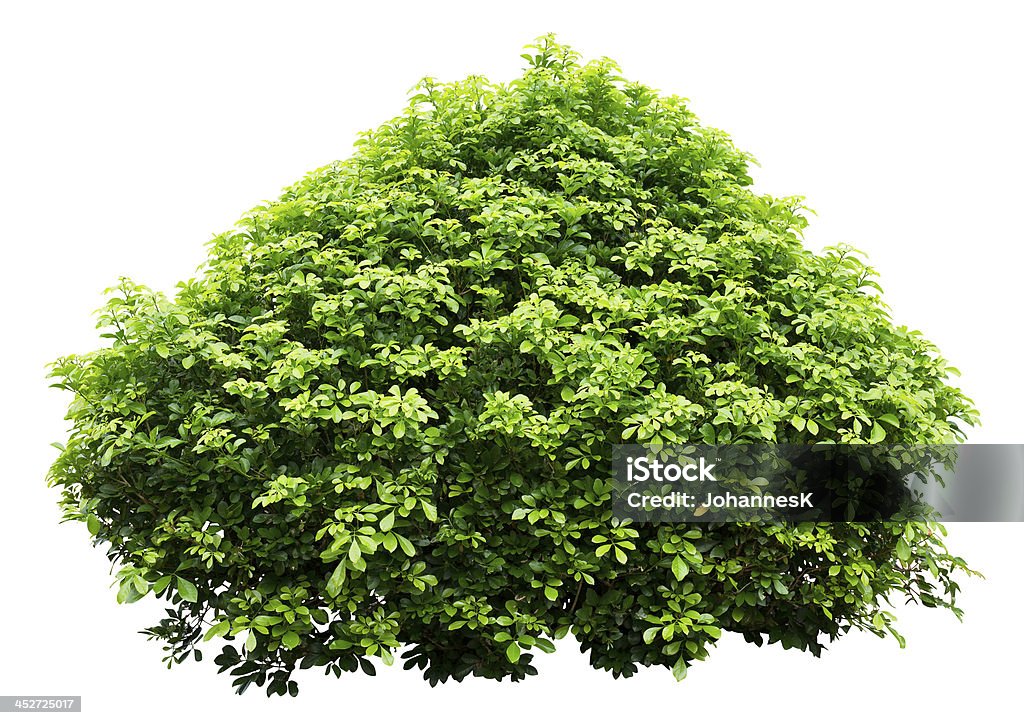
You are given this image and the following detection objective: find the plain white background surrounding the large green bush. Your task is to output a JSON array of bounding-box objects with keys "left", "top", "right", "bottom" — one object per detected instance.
[{"left": 0, "top": 0, "right": 1024, "bottom": 723}]
